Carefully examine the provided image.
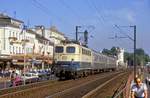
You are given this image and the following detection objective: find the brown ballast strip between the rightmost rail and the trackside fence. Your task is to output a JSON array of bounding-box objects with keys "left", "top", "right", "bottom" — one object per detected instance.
[{"left": 82, "top": 73, "right": 129, "bottom": 98}]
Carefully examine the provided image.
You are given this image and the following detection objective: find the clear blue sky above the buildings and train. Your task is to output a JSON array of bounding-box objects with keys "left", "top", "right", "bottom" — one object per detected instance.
[{"left": 0, "top": 0, "right": 150, "bottom": 54}]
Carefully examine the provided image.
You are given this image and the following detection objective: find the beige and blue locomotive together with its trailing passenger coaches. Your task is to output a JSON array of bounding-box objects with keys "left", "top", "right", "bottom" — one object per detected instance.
[{"left": 54, "top": 43, "right": 116, "bottom": 79}]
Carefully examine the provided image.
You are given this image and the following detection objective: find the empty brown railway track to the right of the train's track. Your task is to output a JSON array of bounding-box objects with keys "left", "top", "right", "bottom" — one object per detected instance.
[{"left": 46, "top": 73, "right": 126, "bottom": 98}]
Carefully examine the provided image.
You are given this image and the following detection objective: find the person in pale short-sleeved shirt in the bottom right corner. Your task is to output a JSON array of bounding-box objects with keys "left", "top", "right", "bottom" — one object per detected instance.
[{"left": 131, "top": 77, "right": 148, "bottom": 98}]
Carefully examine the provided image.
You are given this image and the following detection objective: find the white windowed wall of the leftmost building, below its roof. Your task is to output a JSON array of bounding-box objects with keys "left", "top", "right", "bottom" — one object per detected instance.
[{"left": 0, "top": 27, "right": 22, "bottom": 55}]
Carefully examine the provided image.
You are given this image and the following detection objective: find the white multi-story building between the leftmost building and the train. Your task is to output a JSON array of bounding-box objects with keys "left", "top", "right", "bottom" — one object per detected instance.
[{"left": 12, "top": 29, "right": 53, "bottom": 68}]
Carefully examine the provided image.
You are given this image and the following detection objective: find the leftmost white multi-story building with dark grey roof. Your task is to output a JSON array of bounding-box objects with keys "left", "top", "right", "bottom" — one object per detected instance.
[{"left": 0, "top": 14, "right": 23, "bottom": 69}]
